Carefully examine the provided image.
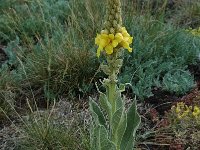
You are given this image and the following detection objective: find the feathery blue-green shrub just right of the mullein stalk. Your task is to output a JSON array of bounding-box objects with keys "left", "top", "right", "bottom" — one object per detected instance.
[{"left": 121, "top": 16, "right": 200, "bottom": 99}]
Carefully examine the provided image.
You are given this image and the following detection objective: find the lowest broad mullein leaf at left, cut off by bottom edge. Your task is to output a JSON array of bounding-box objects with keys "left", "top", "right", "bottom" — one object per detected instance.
[{"left": 91, "top": 125, "right": 116, "bottom": 150}]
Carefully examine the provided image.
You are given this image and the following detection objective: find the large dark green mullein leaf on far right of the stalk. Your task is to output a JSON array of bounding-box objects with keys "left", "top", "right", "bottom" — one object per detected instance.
[{"left": 120, "top": 101, "right": 141, "bottom": 150}]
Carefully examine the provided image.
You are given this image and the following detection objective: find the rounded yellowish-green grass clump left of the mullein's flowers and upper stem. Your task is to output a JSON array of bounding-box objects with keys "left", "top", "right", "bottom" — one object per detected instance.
[{"left": 19, "top": 31, "right": 97, "bottom": 98}]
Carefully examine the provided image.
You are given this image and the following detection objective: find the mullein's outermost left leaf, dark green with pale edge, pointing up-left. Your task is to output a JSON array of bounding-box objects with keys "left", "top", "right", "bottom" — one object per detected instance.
[{"left": 89, "top": 97, "right": 106, "bottom": 128}]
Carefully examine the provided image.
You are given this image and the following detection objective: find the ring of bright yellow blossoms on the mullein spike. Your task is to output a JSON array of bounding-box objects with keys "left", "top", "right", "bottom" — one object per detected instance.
[{"left": 95, "top": 27, "right": 133, "bottom": 57}]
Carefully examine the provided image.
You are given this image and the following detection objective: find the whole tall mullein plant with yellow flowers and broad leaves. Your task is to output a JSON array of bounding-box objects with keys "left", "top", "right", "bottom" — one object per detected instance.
[{"left": 89, "top": 0, "right": 140, "bottom": 150}]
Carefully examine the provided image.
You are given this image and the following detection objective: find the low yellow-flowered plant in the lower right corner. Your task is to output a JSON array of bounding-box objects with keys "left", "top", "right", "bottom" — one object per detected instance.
[{"left": 169, "top": 102, "right": 200, "bottom": 149}]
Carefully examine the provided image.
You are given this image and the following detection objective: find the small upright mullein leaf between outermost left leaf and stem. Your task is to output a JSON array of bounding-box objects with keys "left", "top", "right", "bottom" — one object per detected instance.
[{"left": 99, "top": 92, "right": 112, "bottom": 118}]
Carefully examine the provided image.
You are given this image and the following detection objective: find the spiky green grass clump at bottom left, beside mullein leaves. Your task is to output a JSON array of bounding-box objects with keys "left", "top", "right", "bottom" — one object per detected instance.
[{"left": 15, "top": 106, "right": 89, "bottom": 150}]
